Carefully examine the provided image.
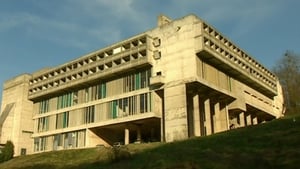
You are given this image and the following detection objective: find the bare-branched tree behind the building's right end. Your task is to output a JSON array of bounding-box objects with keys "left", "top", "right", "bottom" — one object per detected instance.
[{"left": 273, "top": 51, "right": 300, "bottom": 114}]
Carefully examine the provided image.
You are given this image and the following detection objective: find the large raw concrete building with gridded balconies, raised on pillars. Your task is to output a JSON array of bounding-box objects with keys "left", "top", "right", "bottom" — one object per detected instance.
[{"left": 0, "top": 15, "right": 283, "bottom": 155}]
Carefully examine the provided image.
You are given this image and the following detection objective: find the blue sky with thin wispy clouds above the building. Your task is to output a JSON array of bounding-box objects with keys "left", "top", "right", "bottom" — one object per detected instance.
[{"left": 0, "top": 0, "right": 300, "bottom": 105}]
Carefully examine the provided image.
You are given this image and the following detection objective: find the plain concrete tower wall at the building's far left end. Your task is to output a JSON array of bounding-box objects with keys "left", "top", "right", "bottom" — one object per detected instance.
[{"left": 1, "top": 75, "right": 33, "bottom": 155}]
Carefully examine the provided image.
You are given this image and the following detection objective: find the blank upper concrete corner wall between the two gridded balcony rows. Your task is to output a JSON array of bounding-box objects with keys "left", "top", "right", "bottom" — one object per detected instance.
[{"left": 147, "top": 16, "right": 196, "bottom": 84}]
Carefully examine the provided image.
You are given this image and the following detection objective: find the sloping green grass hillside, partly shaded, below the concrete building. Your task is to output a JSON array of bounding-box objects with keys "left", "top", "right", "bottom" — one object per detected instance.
[{"left": 0, "top": 116, "right": 300, "bottom": 169}]
